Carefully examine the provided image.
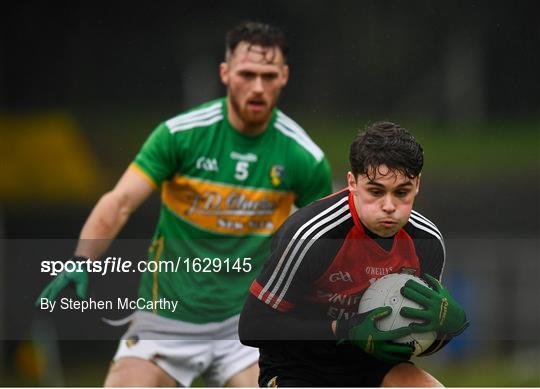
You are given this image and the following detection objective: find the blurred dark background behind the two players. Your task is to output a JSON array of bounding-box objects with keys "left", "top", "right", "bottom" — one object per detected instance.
[{"left": 0, "top": 0, "right": 540, "bottom": 387}]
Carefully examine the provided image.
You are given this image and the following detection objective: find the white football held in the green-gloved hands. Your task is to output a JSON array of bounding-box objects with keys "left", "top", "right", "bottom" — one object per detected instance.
[{"left": 358, "top": 273, "right": 437, "bottom": 355}]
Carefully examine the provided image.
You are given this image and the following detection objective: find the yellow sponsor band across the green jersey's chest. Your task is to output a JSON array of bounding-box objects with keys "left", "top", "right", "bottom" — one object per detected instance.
[{"left": 161, "top": 175, "right": 295, "bottom": 236}]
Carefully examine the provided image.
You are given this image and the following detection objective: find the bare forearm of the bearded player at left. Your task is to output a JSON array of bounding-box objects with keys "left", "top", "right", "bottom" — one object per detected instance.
[{"left": 75, "top": 168, "right": 154, "bottom": 260}]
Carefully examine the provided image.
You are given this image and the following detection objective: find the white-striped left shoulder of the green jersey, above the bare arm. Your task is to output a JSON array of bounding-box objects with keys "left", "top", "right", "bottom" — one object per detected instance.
[{"left": 163, "top": 98, "right": 225, "bottom": 134}]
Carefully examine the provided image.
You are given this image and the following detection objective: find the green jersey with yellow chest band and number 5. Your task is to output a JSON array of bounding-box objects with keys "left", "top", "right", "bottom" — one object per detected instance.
[{"left": 131, "top": 98, "right": 331, "bottom": 323}]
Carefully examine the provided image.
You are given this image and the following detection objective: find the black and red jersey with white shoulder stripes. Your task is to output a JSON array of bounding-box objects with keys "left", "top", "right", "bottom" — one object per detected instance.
[{"left": 239, "top": 189, "right": 445, "bottom": 386}]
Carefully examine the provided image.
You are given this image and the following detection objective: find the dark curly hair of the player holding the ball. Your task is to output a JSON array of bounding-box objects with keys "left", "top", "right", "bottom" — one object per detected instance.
[{"left": 349, "top": 122, "right": 424, "bottom": 179}]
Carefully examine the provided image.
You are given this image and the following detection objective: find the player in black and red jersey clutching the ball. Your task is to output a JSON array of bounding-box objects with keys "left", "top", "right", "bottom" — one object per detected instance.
[{"left": 240, "top": 122, "right": 467, "bottom": 387}]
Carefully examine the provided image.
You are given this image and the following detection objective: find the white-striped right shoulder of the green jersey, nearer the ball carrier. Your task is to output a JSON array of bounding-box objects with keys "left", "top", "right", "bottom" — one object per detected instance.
[{"left": 274, "top": 109, "right": 324, "bottom": 163}]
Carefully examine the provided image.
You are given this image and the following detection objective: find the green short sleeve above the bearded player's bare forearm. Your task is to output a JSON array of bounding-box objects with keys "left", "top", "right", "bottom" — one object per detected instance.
[{"left": 133, "top": 124, "right": 180, "bottom": 186}]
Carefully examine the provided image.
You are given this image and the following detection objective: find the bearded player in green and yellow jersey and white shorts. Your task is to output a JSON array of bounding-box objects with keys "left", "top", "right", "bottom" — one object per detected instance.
[{"left": 38, "top": 22, "right": 331, "bottom": 386}]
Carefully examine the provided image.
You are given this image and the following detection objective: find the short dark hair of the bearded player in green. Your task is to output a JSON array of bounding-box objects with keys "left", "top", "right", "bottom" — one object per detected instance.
[{"left": 225, "top": 21, "right": 289, "bottom": 63}]
